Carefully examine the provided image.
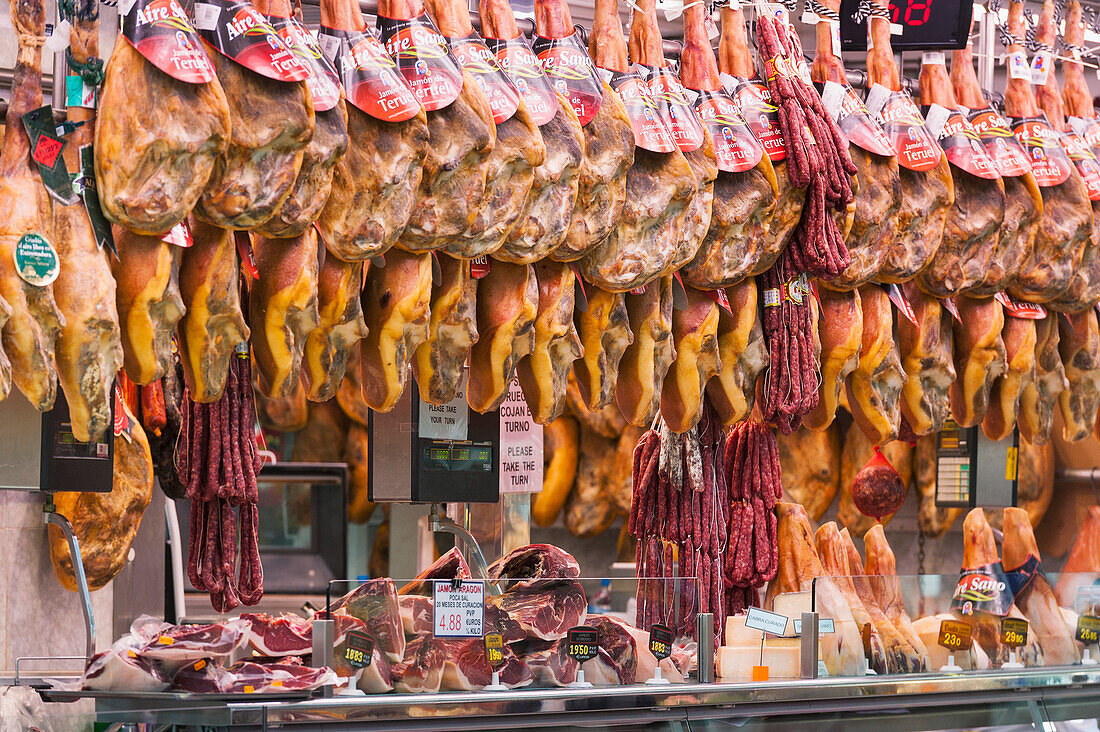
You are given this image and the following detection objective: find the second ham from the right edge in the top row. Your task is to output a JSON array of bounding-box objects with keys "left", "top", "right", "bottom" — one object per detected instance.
[{"left": 1004, "top": 1, "right": 1092, "bottom": 303}]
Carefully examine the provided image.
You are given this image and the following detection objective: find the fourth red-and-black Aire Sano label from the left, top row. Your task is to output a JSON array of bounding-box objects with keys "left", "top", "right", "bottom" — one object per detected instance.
[{"left": 317, "top": 25, "right": 420, "bottom": 122}]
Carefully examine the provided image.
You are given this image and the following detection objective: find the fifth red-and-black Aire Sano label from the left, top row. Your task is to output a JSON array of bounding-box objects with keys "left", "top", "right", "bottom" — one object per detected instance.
[{"left": 378, "top": 11, "right": 462, "bottom": 112}]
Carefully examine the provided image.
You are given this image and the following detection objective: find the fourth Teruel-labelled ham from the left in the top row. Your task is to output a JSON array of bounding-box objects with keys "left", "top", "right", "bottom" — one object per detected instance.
[{"left": 317, "top": 0, "right": 428, "bottom": 262}]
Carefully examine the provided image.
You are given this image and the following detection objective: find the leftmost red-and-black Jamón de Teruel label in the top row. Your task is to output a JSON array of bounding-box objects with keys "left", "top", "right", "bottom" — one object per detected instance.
[{"left": 119, "top": 0, "right": 215, "bottom": 84}]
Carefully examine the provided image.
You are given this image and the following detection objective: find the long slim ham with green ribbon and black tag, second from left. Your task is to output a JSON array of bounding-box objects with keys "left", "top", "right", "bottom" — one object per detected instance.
[{"left": 54, "top": 3, "right": 122, "bottom": 443}]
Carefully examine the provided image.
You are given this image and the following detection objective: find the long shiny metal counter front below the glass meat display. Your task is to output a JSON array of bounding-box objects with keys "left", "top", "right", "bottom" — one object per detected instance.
[{"left": 43, "top": 666, "right": 1100, "bottom": 731}]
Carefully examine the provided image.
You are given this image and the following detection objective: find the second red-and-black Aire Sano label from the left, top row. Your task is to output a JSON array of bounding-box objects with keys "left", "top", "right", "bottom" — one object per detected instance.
[{"left": 195, "top": 0, "right": 309, "bottom": 81}]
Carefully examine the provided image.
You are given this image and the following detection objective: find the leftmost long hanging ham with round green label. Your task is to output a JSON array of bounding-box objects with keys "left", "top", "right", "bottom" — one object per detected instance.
[{"left": 0, "top": 0, "right": 64, "bottom": 412}]
